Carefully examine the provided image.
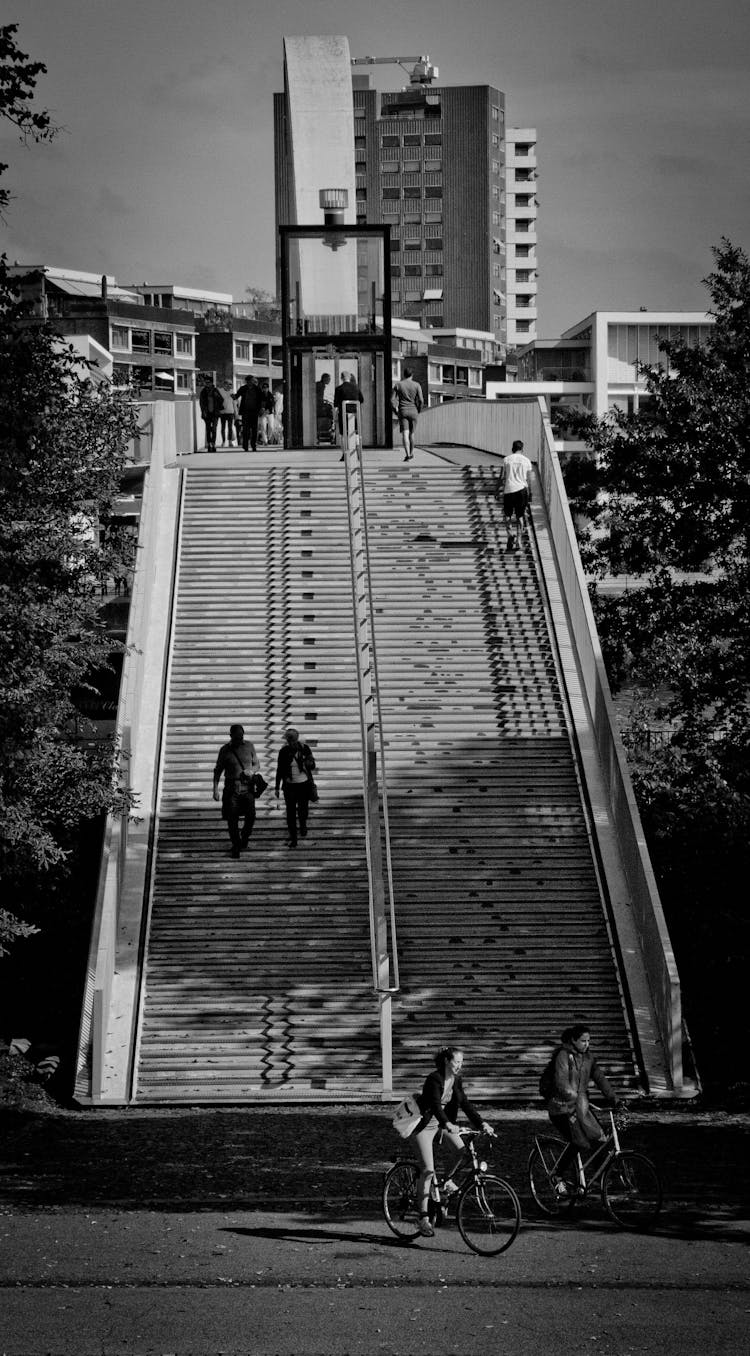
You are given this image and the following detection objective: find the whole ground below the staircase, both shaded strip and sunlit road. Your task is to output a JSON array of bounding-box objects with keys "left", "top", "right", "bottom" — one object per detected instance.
[{"left": 0, "top": 1108, "right": 750, "bottom": 1356}]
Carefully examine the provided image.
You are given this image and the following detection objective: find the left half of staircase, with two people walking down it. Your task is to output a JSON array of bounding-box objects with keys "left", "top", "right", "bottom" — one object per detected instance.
[{"left": 136, "top": 466, "right": 380, "bottom": 1102}]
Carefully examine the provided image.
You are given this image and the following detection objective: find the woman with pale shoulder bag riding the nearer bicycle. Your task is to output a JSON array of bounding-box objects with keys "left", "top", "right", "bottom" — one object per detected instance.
[{"left": 410, "top": 1045, "right": 494, "bottom": 1238}]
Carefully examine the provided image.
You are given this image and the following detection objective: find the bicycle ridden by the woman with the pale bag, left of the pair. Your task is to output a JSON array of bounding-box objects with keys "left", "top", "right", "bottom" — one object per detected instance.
[{"left": 382, "top": 1130, "right": 521, "bottom": 1257}]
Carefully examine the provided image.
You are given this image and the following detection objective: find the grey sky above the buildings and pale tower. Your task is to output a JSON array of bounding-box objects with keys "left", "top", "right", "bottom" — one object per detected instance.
[{"left": 0, "top": 0, "right": 750, "bottom": 336}]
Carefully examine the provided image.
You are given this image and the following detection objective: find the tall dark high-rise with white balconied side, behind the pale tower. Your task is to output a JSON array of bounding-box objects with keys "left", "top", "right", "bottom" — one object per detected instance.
[{"left": 274, "top": 73, "right": 537, "bottom": 353}]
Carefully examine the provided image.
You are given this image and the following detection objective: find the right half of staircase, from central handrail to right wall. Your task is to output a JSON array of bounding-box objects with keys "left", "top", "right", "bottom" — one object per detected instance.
[{"left": 366, "top": 465, "right": 636, "bottom": 1096}]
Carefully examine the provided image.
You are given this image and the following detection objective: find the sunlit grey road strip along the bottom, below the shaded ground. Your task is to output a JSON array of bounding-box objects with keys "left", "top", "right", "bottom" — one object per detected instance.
[{"left": 0, "top": 1210, "right": 750, "bottom": 1356}]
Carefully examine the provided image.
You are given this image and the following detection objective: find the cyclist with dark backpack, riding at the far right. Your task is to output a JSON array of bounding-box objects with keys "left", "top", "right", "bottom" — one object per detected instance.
[{"left": 538, "top": 1022, "right": 620, "bottom": 1196}]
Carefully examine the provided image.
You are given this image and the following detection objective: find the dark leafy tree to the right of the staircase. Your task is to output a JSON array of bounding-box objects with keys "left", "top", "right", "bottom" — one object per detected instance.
[{"left": 564, "top": 240, "right": 750, "bottom": 1090}]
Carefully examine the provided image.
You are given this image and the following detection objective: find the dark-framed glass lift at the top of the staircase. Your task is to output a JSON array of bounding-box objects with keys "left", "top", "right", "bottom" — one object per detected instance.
[{"left": 279, "top": 222, "right": 393, "bottom": 449}]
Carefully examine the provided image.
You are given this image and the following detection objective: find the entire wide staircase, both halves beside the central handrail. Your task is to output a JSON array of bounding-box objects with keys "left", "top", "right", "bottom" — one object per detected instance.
[{"left": 136, "top": 464, "right": 636, "bottom": 1102}]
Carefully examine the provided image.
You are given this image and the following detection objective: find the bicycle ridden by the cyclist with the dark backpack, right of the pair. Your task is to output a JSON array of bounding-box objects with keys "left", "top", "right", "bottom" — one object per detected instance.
[{"left": 528, "top": 1108, "right": 662, "bottom": 1230}]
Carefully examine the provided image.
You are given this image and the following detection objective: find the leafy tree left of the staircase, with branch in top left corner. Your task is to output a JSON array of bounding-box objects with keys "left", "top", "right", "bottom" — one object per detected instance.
[{"left": 0, "top": 24, "right": 134, "bottom": 953}]
